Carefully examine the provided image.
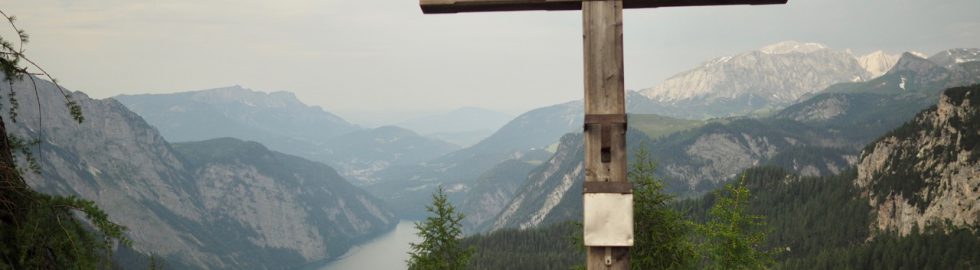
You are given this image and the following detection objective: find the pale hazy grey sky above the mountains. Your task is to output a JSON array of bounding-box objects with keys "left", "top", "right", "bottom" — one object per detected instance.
[{"left": 0, "top": 0, "right": 980, "bottom": 124}]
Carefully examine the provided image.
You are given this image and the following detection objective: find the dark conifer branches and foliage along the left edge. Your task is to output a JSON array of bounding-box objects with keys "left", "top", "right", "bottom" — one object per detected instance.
[{"left": 0, "top": 11, "right": 129, "bottom": 269}]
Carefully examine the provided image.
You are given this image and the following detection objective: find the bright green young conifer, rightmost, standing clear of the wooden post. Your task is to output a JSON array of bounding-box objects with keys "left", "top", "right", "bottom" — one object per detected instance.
[{"left": 699, "top": 175, "right": 774, "bottom": 270}]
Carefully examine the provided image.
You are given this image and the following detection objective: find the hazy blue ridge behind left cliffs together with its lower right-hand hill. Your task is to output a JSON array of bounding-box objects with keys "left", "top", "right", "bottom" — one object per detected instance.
[{"left": 114, "top": 86, "right": 459, "bottom": 185}]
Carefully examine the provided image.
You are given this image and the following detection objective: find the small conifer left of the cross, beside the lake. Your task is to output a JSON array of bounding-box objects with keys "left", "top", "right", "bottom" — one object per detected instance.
[{"left": 408, "top": 186, "right": 473, "bottom": 270}]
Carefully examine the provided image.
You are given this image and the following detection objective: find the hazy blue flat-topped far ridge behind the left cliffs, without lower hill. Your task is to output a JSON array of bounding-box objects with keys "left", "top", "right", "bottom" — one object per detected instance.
[{"left": 113, "top": 85, "right": 359, "bottom": 143}]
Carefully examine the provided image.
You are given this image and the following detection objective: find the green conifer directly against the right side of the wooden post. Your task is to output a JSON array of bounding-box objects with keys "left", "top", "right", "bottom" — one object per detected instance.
[{"left": 629, "top": 146, "right": 697, "bottom": 269}]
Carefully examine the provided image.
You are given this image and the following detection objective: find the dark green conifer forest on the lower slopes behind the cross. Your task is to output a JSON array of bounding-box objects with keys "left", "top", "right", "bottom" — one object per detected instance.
[{"left": 463, "top": 167, "right": 980, "bottom": 269}]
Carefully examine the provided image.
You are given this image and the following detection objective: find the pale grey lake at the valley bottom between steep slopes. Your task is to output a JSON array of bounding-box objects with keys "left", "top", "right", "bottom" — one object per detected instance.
[{"left": 318, "top": 220, "right": 419, "bottom": 270}]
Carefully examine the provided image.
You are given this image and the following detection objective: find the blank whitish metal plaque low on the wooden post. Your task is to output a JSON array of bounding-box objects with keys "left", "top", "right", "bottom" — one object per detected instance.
[{"left": 582, "top": 193, "right": 633, "bottom": 247}]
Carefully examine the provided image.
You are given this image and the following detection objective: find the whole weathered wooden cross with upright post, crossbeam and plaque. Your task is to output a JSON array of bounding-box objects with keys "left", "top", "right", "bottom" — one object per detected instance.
[{"left": 419, "top": 0, "right": 787, "bottom": 270}]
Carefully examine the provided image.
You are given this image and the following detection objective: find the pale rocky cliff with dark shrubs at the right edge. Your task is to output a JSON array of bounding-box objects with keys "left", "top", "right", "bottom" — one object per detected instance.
[{"left": 856, "top": 86, "right": 980, "bottom": 235}]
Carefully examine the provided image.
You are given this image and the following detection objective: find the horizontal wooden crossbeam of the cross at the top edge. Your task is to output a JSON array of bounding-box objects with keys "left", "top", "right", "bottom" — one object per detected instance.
[{"left": 419, "top": 0, "right": 787, "bottom": 14}]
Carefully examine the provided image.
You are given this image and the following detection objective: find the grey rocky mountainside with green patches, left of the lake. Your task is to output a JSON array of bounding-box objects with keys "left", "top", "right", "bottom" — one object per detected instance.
[{"left": 3, "top": 77, "right": 395, "bottom": 269}]
